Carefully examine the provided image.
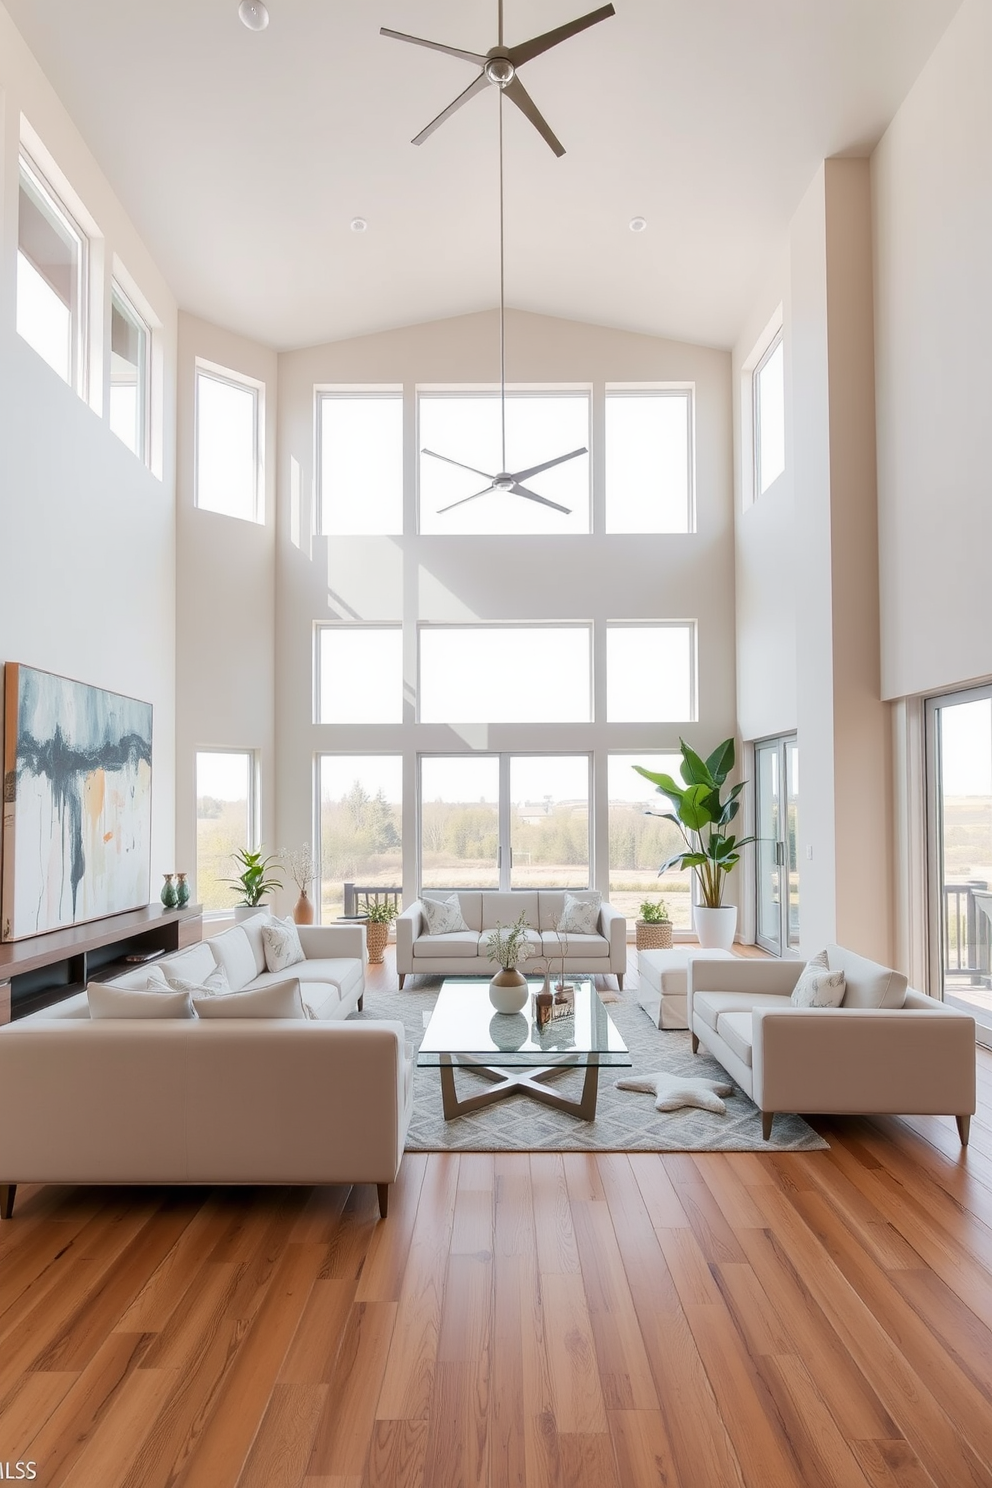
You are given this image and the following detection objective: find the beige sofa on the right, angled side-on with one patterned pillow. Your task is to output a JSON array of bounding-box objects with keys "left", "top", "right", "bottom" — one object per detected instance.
[{"left": 687, "top": 945, "right": 976, "bottom": 1143}]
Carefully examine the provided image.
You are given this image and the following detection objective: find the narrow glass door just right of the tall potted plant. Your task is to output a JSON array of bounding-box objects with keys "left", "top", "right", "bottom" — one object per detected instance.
[{"left": 754, "top": 737, "right": 799, "bottom": 955}]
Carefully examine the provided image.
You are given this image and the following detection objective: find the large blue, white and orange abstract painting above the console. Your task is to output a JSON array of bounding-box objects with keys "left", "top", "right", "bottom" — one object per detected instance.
[{"left": 0, "top": 662, "right": 152, "bottom": 940}]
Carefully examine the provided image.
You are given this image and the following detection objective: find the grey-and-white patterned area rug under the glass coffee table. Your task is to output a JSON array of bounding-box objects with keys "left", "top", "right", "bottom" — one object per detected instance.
[{"left": 352, "top": 978, "right": 830, "bottom": 1152}]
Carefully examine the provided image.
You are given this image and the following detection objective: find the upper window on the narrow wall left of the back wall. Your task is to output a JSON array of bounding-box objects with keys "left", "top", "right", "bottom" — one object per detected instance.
[{"left": 196, "top": 362, "right": 263, "bottom": 522}]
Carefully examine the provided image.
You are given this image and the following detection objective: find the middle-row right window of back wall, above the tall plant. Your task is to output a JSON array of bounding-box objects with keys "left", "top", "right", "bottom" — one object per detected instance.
[{"left": 607, "top": 623, "right": 696, "bottom": 723}]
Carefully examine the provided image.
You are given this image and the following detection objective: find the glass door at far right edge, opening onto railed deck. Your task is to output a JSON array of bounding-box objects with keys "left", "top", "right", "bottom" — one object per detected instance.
[{"left": 927, "top": 687, "right": 992, "bottom": 1042}]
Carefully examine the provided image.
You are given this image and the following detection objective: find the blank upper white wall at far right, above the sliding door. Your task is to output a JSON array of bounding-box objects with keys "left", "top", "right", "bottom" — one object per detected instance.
[{"left": 872, "top": 0, "right": 992, "bottom": 698}]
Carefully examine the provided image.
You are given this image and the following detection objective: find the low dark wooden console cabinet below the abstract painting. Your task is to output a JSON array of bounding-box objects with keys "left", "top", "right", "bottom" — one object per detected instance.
[{"left": 0, "top": 905, "right": 204, "bottom": 1024}]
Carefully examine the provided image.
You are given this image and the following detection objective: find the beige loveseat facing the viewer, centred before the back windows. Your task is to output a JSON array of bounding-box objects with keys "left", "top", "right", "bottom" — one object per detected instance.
[{"left": 396, "top": 888, "right": 628, "bottom": 987}]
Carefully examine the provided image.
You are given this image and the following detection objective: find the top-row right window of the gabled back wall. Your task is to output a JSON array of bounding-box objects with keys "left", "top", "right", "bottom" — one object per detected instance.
[{"left": 607, "top": 388, "right": 693, "bottom": 533}]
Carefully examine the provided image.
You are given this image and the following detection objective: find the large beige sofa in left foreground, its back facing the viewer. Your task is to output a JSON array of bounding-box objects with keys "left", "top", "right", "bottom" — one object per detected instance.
[{"left": 0, "top": 926, "right": 413, "bottom": 1217}]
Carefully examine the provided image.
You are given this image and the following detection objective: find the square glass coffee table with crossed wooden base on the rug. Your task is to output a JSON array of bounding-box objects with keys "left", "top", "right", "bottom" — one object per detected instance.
[{"left": 416, "top": 976, "right": 631, "bottom": 1120}]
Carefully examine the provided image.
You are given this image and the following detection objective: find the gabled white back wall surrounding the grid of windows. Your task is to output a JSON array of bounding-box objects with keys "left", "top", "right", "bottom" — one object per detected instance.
[{"left": 275, "top": 312, "right": 735, "bottom": 894}]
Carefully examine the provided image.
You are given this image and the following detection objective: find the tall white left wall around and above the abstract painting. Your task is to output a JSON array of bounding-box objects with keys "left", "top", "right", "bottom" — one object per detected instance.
[{"left": 0, "top": 7, "right": 175, "bottom": 893}]
